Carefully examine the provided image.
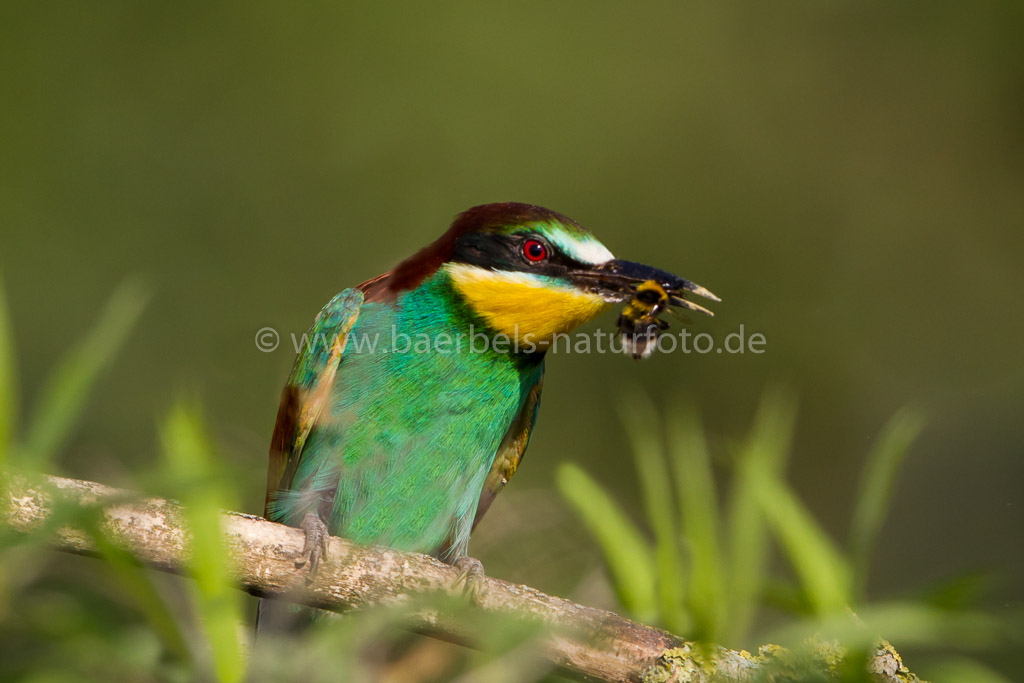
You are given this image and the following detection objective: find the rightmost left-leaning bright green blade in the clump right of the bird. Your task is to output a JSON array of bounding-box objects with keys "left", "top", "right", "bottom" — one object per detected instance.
[{"left": 756, "top": 477, "right": 852, "bottom": 614}]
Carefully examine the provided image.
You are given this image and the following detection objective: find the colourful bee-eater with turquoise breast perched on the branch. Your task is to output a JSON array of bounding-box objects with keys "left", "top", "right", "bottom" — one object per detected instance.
[{"left": 261, "top": 202, "right": 718, "bottom": 630}]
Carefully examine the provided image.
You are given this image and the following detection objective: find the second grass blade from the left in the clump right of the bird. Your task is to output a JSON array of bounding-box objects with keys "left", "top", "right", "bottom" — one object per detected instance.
[{"left": 620, "top": 392, "right": 690, "bottom": 633}]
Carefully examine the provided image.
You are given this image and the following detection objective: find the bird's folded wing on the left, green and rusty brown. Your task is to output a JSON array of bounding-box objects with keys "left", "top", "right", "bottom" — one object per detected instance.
[{"left": 264, "top": 289, "right": 364, "bottom": 518}]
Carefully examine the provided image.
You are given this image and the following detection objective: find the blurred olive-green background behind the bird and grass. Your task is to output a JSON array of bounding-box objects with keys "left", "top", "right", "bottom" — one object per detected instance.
[{"left": 0, "top": 0, "right": 1024, "bottom": 679}]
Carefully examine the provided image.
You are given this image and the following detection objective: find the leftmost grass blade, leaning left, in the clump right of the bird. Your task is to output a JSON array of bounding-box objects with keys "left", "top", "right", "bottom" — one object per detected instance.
[{"left": 555, "top": 463, "right": 657, "bottom": 620}]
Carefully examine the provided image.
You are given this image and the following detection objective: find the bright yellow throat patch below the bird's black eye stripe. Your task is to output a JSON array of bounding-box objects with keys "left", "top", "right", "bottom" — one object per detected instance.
[{"left": 445, "top": 263, "right": 610, "bottom": 344}]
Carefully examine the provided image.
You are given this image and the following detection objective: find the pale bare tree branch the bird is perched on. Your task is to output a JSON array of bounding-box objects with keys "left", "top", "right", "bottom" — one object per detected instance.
[{"left": 0, "top": 476, "right": 918, "bottom": 682}]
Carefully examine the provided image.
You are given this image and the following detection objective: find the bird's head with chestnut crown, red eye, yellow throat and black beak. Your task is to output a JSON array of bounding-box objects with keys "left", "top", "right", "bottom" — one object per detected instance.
[{"left": 362, "top": 203, "right": 718, "bottom": 344}]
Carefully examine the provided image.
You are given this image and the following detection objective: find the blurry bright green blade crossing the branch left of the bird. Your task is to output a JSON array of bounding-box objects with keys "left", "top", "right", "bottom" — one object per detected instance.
[{"left": 162, "top": 405, "right": 245, "bottom": 683}]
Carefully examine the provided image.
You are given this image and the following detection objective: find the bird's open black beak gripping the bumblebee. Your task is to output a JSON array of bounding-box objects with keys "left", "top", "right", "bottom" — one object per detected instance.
[{"left": 571, "top": 258, "right": 721, "bottom": 315}]
